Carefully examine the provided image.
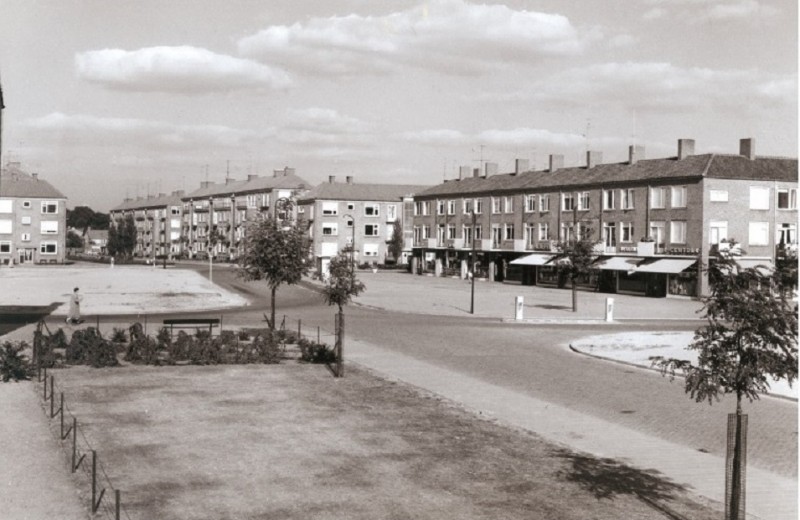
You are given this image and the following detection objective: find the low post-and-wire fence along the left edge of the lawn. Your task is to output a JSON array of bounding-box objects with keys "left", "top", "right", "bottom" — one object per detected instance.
[{"left": 36, "top": 368, "right": 130, "bottom": 520}]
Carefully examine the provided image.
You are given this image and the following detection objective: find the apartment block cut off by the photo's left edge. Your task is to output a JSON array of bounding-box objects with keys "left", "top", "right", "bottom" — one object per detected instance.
[{"left": 0, "top": 162, "right": 67, "bottom": 265}]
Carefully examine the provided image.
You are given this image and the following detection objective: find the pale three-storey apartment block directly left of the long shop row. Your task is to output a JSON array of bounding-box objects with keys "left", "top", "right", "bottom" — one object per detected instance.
[{"left": 298, "top": 175, "right": 428, "bottom": 272}]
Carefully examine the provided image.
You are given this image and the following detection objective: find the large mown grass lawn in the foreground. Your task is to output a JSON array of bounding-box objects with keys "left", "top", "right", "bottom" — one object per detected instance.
[{"left": 45, "top": 363, "right": 720, "bottom": 520}]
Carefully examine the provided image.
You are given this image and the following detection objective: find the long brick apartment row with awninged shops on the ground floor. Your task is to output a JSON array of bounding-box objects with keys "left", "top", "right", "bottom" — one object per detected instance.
[{"left": 412, "top": 139, "right": 797, "bottom": 296}]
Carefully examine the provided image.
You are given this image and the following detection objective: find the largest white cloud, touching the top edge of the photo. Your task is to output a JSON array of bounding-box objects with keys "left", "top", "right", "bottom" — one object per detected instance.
[{"left": 238, "top": 0, "right": 583, "bottom": 74}]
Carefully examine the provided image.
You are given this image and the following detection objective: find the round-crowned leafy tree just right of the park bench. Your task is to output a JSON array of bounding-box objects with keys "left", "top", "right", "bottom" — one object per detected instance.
[{"left": 239, "top": 218, "right": 309, "bottom": 330}]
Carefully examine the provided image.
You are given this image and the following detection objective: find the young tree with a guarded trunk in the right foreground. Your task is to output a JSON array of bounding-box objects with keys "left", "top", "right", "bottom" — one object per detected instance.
[{"left": 652, "top": 244, "right": 797, "bottom": 519}]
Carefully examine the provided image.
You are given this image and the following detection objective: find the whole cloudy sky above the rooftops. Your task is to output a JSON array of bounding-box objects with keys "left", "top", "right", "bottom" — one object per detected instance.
[{"left": 0, "top": 0, "right": 798, "bottom": 210}]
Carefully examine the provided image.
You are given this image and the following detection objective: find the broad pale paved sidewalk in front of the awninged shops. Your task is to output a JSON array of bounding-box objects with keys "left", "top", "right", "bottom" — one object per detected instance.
[{"left": 346, "top": 271, "right": 702, "bottom": 323}]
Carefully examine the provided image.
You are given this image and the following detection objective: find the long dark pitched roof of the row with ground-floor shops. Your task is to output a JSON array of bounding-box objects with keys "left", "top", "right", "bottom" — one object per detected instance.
[{"left": 417, "top": 154, "right": 797, "bottom": 198}]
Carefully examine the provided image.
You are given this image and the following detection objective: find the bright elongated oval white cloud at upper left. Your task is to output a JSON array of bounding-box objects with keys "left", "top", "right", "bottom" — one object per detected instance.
[{"left": 75, "top": 46, "right": 291, "bottom": 93}]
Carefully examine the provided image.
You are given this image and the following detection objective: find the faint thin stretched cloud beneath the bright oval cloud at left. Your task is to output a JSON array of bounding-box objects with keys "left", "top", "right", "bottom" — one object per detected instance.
[{"left": 24, "top": 112, "right": 268, "bottom": 150}]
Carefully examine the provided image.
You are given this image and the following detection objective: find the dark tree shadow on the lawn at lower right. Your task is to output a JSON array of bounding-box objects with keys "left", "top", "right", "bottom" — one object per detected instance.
[{"left": 557, "top": 450, "right": 686, "bottom": 506}]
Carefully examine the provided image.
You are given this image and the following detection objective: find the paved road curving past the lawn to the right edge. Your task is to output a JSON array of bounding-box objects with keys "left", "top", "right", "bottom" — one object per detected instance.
[{"left": 161, "top": 268, "right": 798, "bottom": 478}]
